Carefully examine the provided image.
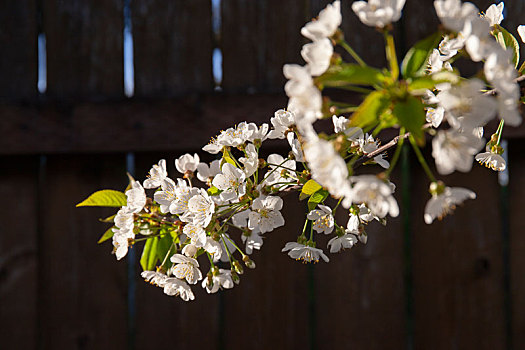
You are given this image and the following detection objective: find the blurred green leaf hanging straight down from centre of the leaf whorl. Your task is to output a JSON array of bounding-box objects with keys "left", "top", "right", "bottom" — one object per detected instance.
[{"left": 392, "top": 96, "right": 425, "bottom": 144}]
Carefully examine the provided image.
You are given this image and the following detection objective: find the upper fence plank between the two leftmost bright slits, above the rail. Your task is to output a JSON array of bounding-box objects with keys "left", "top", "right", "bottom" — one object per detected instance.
[{"left": 43, "top": 0, "right": 124, "bottom": 100}]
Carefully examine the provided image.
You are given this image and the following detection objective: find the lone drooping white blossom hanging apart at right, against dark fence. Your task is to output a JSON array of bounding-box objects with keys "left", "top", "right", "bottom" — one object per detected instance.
[{"left": 424, "top": 182, "right": 476, "bottom": 224}]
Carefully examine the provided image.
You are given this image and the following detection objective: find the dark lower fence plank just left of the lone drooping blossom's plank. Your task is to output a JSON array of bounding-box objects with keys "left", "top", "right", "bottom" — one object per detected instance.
[{"left": 315, "top": 170, "right": 406, "bottom": 349}]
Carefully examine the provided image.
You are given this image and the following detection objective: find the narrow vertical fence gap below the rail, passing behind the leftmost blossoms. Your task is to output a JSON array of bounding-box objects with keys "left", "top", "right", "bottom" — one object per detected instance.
[{"left": 126, "top": 152, "right": 137, "bottom": 350}]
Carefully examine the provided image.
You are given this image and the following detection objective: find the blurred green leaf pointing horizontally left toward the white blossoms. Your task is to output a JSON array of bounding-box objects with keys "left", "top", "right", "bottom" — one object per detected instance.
[{"left": 317, "top": 63, "right": 385, "bottom": 87}]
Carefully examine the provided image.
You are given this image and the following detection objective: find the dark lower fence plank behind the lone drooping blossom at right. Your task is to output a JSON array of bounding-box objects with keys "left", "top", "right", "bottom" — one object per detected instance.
[{"left": 412, "top": 152, "right": 506, "bottom": 349}]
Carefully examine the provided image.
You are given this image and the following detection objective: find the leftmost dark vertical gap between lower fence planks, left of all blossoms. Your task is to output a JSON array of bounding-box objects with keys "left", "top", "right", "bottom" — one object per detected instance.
[{"left": 36, "top": 155, "right": 47, "bottom": 349}]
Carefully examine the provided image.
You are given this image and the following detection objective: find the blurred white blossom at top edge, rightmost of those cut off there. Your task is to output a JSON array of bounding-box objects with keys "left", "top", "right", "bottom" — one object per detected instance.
[{"left": 434, "top": 0, "right": 479, "bottom": 32}]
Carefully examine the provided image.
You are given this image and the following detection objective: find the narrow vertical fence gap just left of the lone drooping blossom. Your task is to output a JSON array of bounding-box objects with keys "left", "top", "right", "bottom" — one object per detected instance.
[{"left": 401, "top": 144, "right": 414, "bottom": 350}]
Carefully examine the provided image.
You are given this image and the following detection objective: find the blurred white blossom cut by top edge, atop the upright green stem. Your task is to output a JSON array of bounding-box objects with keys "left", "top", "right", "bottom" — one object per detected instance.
[{"left": 352, "top": 0, "right": 405, "bottom": 28}]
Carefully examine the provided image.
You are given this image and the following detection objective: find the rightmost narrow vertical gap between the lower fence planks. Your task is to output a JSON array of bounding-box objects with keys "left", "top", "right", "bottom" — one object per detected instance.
[{"left": 498, "top": 140, "right": 513, "bottom": 349}]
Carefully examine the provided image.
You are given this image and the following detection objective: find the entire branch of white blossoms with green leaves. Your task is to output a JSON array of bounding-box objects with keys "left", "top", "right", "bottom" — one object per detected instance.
[{"left": 79, "top": 0, "right": 525, "bottom": 300}]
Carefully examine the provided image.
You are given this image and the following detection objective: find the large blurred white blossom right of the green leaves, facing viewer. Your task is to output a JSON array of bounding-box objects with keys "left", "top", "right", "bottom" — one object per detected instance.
[{"left": 437, "top": 79, "right": 497, "bottom": 130}]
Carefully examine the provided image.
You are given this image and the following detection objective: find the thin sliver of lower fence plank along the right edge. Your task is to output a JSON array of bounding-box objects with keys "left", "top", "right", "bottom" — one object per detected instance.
[{"left": 508, "top": 141, "right": 525, "bottom": 349}]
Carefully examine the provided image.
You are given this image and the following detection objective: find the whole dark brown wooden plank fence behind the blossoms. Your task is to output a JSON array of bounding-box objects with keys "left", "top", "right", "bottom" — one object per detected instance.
[{"left": 0, "top": 0, "right": 525, "bottom": 349}]
